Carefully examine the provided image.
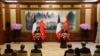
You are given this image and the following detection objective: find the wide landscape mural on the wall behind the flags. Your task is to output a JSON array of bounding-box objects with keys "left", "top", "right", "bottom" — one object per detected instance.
[{"left": 21, "top": 10, "right": 80, "bottom": 31}]
